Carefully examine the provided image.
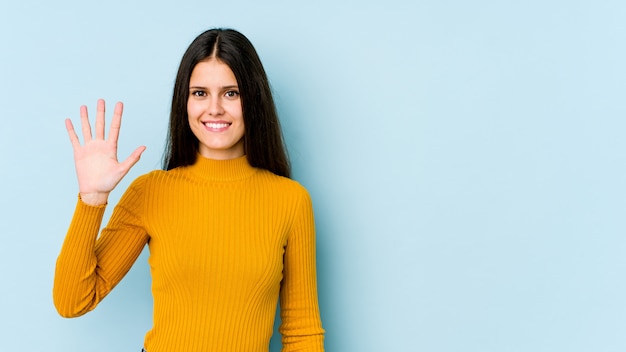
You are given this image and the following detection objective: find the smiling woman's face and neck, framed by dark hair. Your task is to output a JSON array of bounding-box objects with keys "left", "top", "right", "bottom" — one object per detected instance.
[{"left": 187, "top": 58, "right": 245, "bottom": 160}]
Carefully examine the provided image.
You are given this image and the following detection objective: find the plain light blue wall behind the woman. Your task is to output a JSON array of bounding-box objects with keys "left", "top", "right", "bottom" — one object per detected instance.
[{"left": 0, "top": 0, "right": 626, "bottom": 352}]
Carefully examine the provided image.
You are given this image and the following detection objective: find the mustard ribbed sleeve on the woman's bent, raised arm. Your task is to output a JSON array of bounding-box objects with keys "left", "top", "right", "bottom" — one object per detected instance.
[{"left": 52, "top": 178, "right": 148, "bottom": 318}]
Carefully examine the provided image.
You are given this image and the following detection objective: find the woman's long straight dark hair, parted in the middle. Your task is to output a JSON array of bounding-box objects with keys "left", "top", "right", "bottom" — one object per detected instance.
[{"left": 163, "top": 28, "right": 291, "bottom": 177}]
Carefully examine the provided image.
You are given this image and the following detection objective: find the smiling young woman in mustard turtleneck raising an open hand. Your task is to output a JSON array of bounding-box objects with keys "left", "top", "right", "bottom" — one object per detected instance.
[{"left": 53, "top": 29, "right": 324, "bottom": 352}]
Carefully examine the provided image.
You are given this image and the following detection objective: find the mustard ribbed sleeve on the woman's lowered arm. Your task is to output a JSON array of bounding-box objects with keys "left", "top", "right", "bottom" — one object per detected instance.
[{"left": 279, "top": 191, "right": 324, "bottom": 352}]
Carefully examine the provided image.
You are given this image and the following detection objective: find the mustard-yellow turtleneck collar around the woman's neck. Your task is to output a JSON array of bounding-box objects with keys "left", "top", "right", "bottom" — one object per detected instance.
[{"left": 189, "top": 154, "right": 257, "bottom": 181}]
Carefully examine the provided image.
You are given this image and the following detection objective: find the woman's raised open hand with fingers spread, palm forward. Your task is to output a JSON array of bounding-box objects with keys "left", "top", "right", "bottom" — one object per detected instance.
[{"left": 65, "top": 99, "right": 146, "bottom": 205}]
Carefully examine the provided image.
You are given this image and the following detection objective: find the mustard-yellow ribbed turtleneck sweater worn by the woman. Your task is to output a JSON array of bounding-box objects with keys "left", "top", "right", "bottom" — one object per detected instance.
[{"left": 53, "top": 156, "right": 324, "bottom": 352}]
